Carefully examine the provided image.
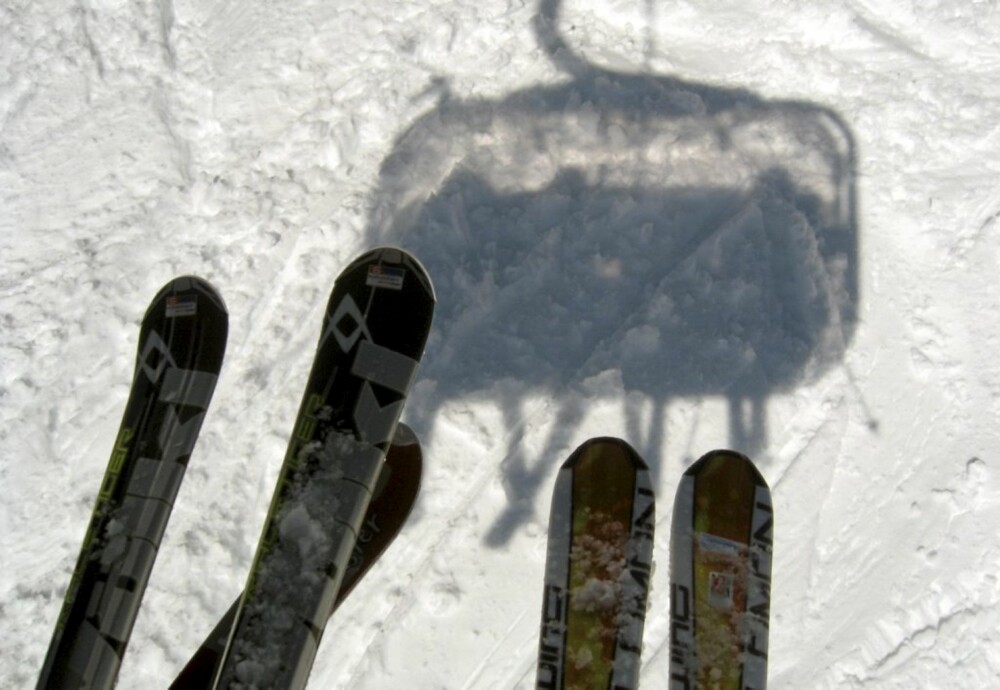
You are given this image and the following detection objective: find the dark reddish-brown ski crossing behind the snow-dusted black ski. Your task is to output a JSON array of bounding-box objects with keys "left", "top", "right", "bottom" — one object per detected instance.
[{"left": 170, "top": 423, "right": 423, "bottom": 690}]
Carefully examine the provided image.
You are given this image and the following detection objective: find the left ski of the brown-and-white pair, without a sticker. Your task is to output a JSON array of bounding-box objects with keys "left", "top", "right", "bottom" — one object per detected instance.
[{"left": 536, "top": 438, "right": 655, "bottom": 690}]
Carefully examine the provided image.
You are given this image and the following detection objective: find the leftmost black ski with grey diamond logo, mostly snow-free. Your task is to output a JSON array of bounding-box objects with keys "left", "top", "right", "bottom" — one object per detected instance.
[{"left": 38, "top": 276, "right": 228, "bottom": 688}]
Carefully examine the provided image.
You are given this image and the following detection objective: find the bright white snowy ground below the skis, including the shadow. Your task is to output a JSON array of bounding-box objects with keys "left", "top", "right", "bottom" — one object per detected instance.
[{"left": 0, "top": 0, "right": 1000, "bottom": 690}]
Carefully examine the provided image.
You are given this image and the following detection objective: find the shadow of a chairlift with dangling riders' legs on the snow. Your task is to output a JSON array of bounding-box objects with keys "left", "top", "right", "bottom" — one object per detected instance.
[{"left": 369, "top": 0, "right": 858, "bottom": 545}]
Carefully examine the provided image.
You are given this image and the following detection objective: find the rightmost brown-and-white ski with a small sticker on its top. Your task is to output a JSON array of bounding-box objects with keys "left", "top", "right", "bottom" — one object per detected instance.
[{"left": 670, "top": 450, "right": 774, "bottom": 690}]
